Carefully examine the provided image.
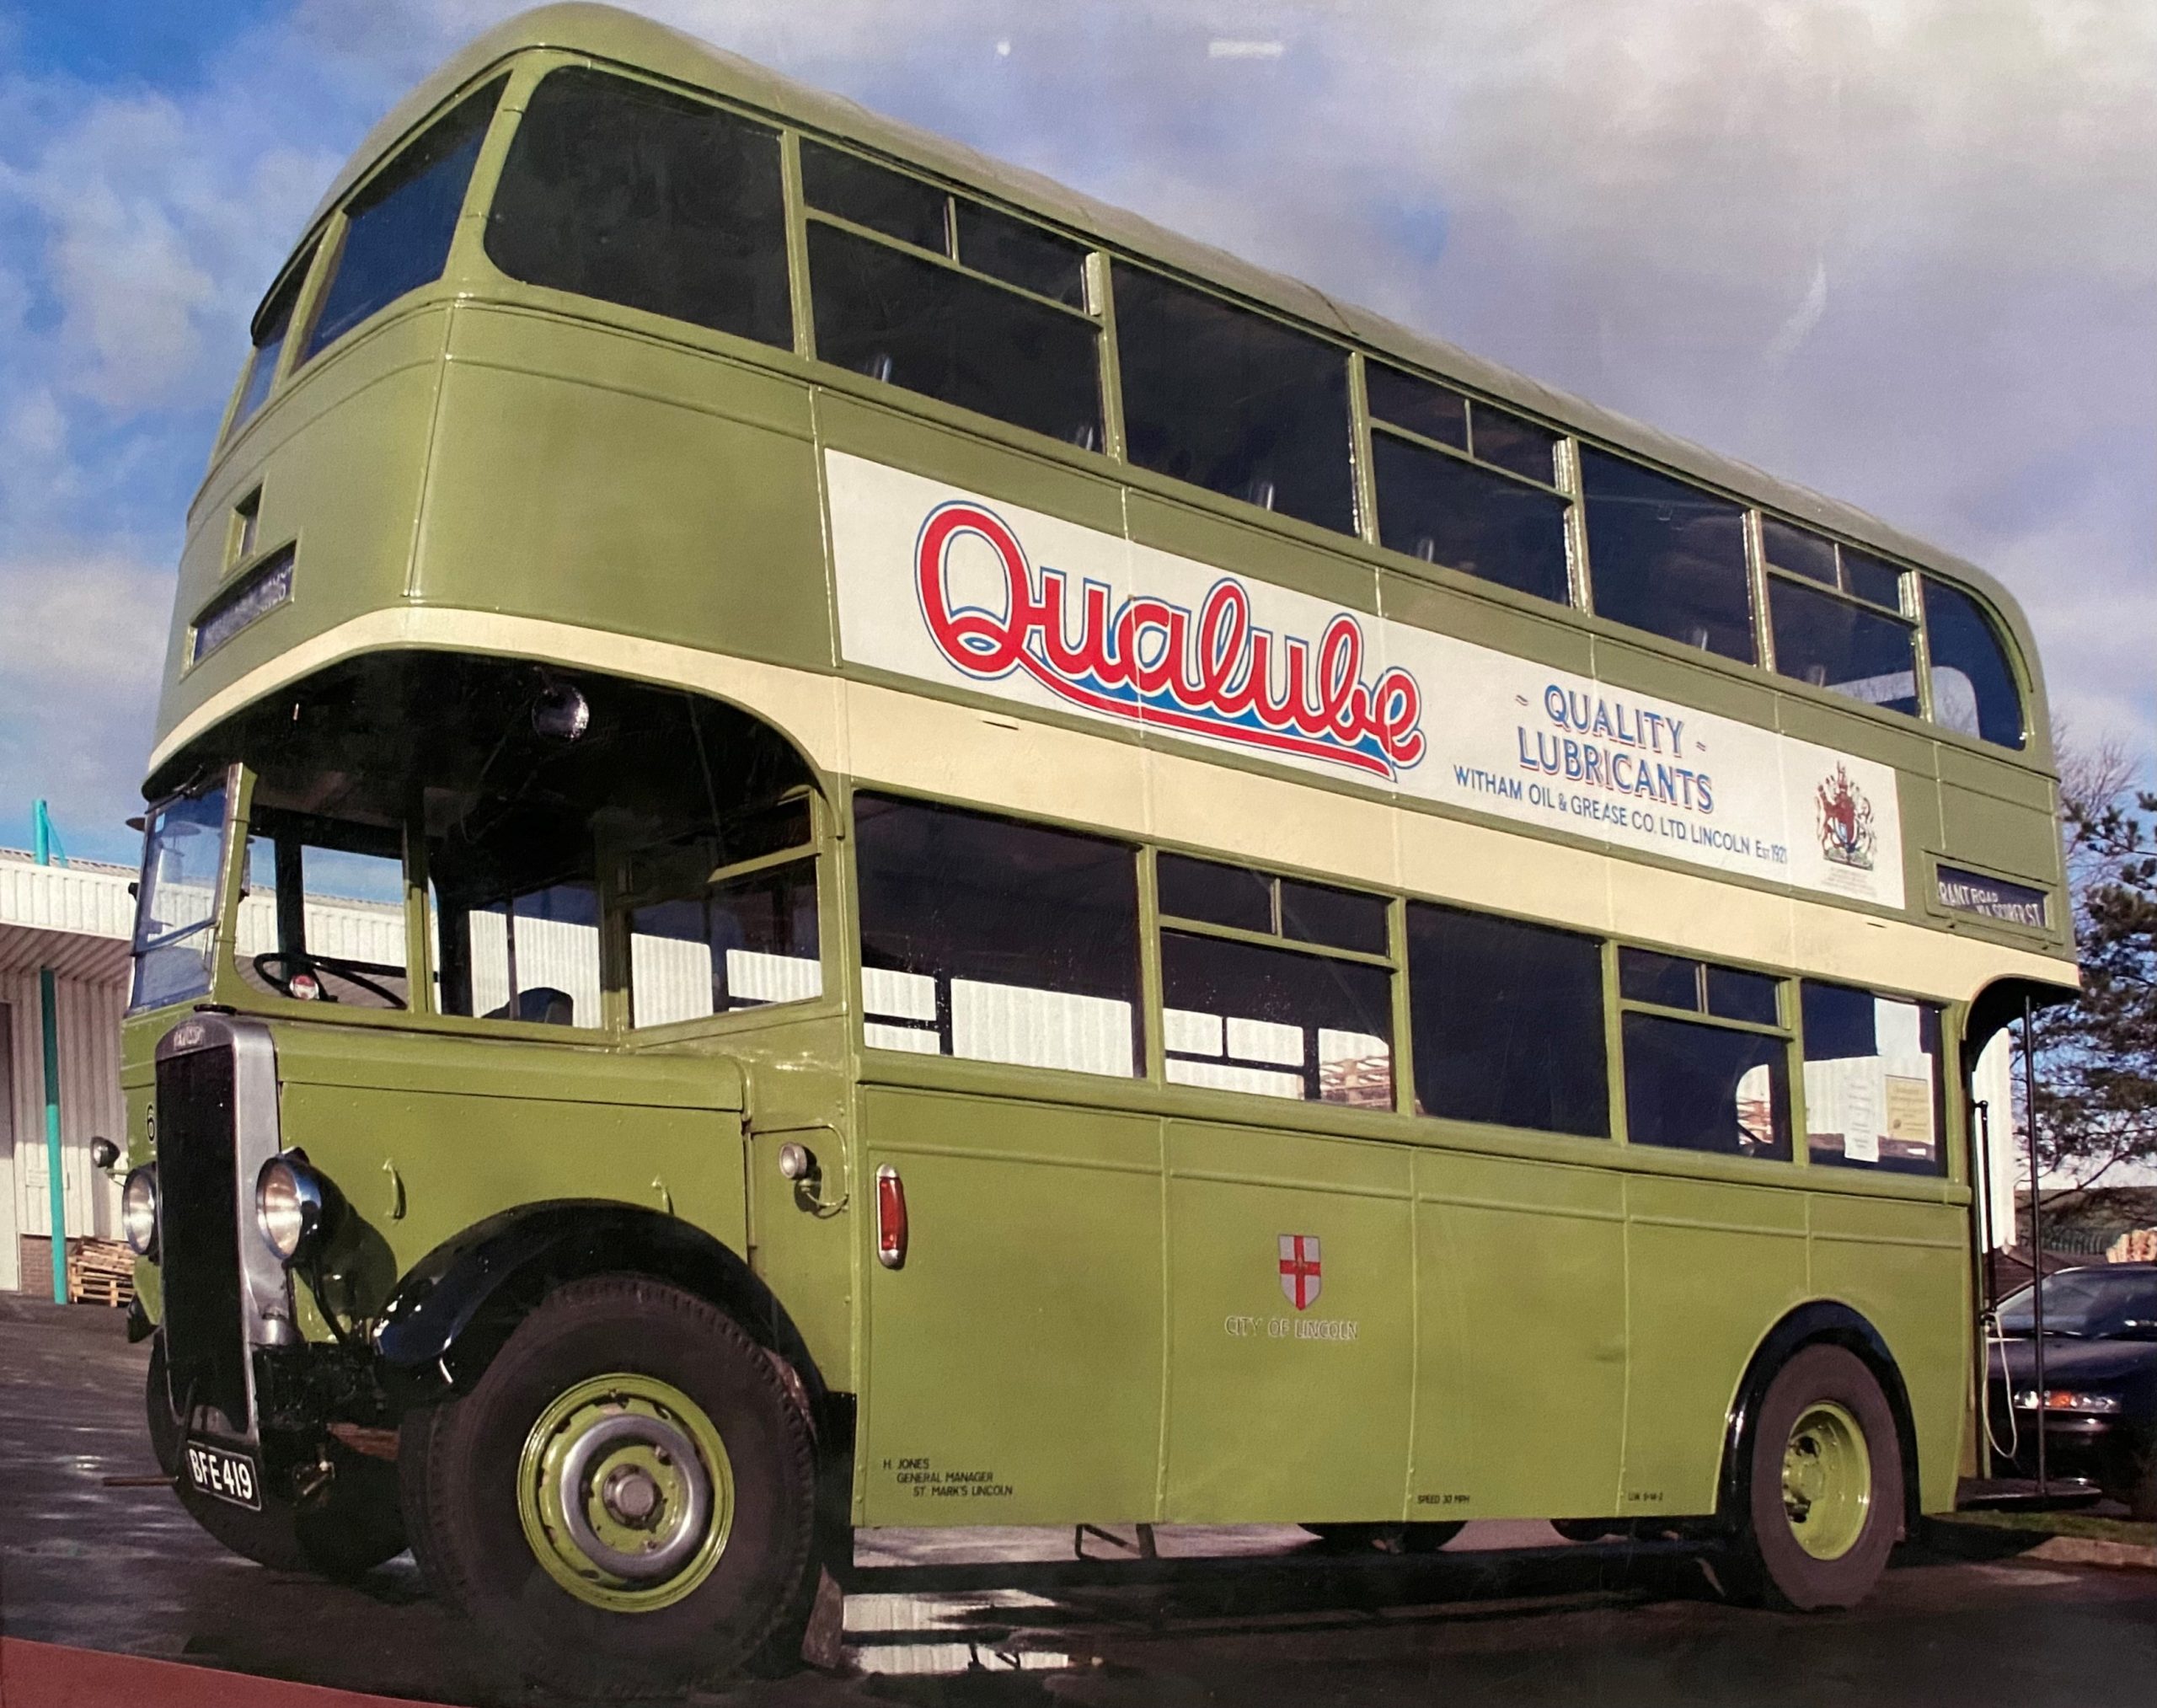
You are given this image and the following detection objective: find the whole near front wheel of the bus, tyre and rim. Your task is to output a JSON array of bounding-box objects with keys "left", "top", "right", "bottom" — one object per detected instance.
[{"left": 401, "top": 1275, "right": 816, "bottom": 1697}]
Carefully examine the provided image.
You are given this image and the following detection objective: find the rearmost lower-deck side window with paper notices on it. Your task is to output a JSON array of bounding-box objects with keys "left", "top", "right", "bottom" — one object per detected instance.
[{"left": 1801, "top": 982, "right": 1948, "bottom": 1173}]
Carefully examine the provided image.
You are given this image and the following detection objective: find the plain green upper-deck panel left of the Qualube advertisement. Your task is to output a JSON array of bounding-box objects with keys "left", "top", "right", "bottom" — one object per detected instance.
[{"left": 416, "top": 308, "right": 832, "bottom": 668}]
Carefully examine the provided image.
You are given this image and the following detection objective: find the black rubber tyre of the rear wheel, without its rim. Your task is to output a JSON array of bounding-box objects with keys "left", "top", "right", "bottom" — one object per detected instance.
[{"left": 1730, "top": 1346, "right": 1903, "bottom": 1613}]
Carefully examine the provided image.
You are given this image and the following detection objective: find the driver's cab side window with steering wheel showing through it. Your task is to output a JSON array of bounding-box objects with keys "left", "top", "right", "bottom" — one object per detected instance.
[{"left": 238, "top": 809, "right": 409, "bottom": 1009}]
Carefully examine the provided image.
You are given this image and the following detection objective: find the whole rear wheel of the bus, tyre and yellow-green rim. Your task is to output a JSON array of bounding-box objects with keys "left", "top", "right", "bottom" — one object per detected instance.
[{"left": 1737, "top": 1346, "right": 1903, "bottom": 1613}]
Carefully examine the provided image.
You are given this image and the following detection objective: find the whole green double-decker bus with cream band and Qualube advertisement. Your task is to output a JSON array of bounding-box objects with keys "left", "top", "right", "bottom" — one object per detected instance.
[{"left": 125, "top": 7, "right": 2075, "bottom": 1691}]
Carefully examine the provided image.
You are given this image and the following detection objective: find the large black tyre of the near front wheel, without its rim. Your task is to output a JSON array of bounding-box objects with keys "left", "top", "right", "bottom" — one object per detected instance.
[{"left": 399, "top": 1275, "right": 816, "bottom": 1700}]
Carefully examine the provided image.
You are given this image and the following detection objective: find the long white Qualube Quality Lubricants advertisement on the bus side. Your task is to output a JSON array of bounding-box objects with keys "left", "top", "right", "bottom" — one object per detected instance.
[{"left": 824, "top": 451, "right": 1903, "bottom": 908}]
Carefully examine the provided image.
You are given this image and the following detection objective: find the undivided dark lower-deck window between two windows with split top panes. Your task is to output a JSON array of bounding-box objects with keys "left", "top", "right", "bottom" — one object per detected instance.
[{"left": 1409, "top": 906, "right": 1609, "bottom": 1138}]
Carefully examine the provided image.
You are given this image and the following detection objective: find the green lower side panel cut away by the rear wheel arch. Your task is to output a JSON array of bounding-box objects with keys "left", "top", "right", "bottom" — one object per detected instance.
[{"left": 1624, "top": 1175, "right": 1810, "bottom": 1518}]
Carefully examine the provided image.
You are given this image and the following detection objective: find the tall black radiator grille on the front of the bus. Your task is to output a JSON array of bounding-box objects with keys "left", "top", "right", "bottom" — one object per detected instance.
[{"left": 158, "top": 1048, "right": 248, "bottom": 1434}]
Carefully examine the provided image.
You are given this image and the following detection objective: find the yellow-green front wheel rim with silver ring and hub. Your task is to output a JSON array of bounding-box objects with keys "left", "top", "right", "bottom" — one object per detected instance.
[{"left": 517, "top": 1373, "right": 733, "bottom": 1613}]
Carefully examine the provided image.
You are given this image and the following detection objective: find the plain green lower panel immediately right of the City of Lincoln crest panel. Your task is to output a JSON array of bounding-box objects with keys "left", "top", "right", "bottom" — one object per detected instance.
[{"left": 1409, "top": 1152, "right": 1626, "bottom": 1518}]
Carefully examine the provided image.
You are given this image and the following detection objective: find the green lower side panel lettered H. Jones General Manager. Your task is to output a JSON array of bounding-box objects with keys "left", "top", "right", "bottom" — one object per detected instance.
[{"left": 856, "top": 1087, "right": 1160, "bottom": 1524}]
